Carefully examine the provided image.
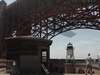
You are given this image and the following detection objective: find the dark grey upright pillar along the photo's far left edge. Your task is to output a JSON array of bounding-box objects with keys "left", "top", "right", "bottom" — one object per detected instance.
[{"left": 0, "top": 0, "right": 7, "bottom": 58}]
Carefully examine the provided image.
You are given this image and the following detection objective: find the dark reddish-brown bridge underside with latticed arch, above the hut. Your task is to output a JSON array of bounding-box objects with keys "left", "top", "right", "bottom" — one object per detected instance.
[{"left": 4, "top": 0, "right": 100, "bottom": 39}]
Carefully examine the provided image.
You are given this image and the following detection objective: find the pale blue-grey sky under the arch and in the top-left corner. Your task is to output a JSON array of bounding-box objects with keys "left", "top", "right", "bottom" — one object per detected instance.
[{"left": 5, "top": 0, "right": 100, "bottom": 59}]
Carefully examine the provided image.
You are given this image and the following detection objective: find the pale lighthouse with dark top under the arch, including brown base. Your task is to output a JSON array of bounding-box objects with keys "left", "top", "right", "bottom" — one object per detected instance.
[{"left": 65, "top": 42, "right": 75, "bottom": 73}]
